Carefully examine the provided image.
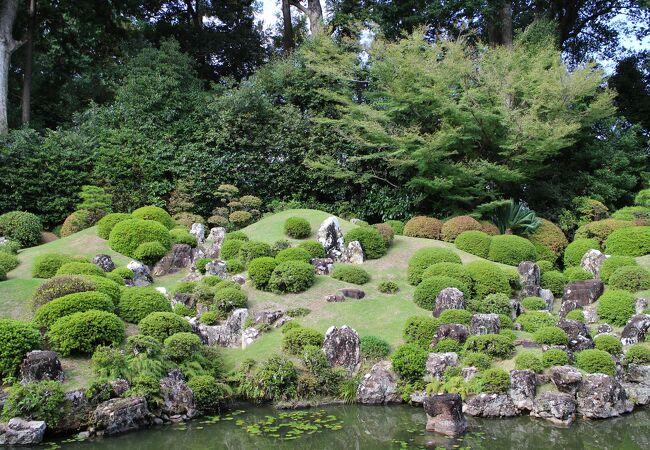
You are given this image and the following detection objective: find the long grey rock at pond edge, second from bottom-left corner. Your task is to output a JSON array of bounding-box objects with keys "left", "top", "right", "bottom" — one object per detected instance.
[{"left": 91, "top": 397, "right": 151, "bottom": 436}]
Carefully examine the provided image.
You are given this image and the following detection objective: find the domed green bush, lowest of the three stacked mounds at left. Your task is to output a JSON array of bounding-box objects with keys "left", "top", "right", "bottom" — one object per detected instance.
[{"left": 47, "top": 310, "right": 124, "bottom": 356}]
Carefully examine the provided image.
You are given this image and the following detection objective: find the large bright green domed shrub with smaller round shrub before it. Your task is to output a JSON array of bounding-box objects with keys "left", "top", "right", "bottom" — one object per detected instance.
[{"left": 108, "top": 219, "right": 171, "bottom": 257}]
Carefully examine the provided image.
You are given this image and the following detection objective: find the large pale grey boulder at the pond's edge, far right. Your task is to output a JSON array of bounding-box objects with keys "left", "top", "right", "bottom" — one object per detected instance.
[{"left": 576, "top": 373, "right": 634, "bottom": 419}]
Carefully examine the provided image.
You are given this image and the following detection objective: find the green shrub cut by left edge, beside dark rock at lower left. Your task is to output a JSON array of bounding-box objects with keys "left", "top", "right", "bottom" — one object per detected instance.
[{"left": 0, "top": 319, "right": 41, "bottom": 378}]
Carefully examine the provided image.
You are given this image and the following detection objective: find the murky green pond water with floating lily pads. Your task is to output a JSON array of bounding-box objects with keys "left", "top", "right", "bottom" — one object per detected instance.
[{"left": 39, "top": 405, "right": 650, "bottom": 450}]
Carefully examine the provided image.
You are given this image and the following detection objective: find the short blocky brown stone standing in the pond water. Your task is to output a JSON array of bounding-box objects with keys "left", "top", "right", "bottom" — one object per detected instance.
[{"left": 424, "top": 394, "right": 467, "bottom": 437}]
